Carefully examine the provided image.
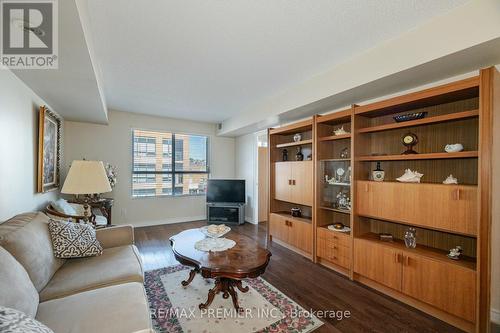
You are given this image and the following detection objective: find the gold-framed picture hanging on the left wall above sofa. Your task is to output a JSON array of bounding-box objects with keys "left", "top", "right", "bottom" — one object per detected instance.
[{"left": 37, "top": 106, "right": 61, "bottom": 192}]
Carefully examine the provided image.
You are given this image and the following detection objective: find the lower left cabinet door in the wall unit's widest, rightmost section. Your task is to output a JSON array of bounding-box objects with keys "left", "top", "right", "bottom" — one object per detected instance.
[{"left": 354, "top": 239, "right": 403, "bottom": 291}]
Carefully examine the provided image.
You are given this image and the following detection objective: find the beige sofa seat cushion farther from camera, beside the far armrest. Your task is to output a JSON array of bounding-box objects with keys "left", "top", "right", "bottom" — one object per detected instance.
[{"left": 40, "top": 245, "right": 144, "bottom": 301}]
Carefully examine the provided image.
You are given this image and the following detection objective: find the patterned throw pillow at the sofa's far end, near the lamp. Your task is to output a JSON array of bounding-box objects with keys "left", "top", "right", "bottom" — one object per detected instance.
[{"left": 49, "top": 220, "right": 102, "bottom": 259}]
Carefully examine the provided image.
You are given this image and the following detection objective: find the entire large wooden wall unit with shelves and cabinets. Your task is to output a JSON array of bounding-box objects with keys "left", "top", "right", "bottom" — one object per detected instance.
[{"left": 269, "top": 67, "right": 500, "bottom": 332}]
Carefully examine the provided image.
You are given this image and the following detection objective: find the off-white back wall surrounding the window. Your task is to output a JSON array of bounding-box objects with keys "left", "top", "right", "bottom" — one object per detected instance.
[{"left": 64, "top": 110, "right": 234, "bottom": 226}]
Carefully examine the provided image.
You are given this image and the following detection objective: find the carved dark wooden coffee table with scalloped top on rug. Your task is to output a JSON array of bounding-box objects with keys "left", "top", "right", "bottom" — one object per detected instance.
[{"left": 170, "top": 229, "right": 271, "bottom": 311}]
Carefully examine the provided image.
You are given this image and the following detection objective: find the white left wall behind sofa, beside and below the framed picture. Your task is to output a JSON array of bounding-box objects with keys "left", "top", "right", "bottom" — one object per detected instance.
[{"left": 0, "top": 69, "right": 59, "bottom": 221}]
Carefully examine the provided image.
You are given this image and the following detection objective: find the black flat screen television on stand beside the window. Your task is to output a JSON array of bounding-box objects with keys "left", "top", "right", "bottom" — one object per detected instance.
[{"left": 207, "top": 179, "right": 245, "bottom": 203}]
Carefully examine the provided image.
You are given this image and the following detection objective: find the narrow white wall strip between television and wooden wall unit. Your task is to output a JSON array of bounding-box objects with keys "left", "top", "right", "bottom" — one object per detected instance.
[{"left": 235, "top": 133, "right": 258, "bottom": 223}]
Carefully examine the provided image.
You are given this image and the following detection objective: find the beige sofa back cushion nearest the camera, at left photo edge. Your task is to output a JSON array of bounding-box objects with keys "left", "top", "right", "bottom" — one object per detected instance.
[{"left": 0, "top": 247, "right": 39, "bottom": 317}]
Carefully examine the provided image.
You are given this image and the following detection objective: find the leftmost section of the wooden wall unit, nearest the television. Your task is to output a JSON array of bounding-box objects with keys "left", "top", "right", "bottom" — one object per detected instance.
[{"left": 268, "top": 119, "right": 315, "bottom": 259}]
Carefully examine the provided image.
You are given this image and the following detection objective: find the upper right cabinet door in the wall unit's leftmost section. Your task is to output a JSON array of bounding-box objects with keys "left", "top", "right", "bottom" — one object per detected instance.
[{"left": 290, "top": 161, "right": 313, "bottom": 206}]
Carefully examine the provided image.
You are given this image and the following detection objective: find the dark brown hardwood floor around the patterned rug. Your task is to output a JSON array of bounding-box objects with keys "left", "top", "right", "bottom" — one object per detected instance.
[{"left": 135, "top": 221, "right": 461, "bottom": 333}]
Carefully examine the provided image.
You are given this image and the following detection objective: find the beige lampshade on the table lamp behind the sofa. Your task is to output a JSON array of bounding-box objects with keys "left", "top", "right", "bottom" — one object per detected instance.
[{"left": 61, "top": 161, "right": 111, "bottom": 194}]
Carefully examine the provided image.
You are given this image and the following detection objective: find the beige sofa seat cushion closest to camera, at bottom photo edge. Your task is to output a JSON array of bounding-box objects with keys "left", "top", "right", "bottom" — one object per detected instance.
[{"left": 36, "top": 282, "right": 151, "bottom": 333}]
